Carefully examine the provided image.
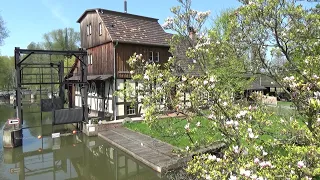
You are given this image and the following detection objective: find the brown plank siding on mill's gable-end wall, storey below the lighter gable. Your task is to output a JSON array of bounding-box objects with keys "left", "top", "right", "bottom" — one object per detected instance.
[{"left": 87, "top": 42, "right": 113, "bottom": 75}]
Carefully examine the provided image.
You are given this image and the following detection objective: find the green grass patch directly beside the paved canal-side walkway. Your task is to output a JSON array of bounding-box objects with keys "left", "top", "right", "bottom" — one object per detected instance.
[{"left": 125, "top": 117, "right": 221, "bottom": 148}]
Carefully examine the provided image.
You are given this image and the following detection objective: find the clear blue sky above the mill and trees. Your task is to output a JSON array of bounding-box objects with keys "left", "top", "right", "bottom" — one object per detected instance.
[{"left": 0, "top": 0, "right": 239, "bottom": 56}]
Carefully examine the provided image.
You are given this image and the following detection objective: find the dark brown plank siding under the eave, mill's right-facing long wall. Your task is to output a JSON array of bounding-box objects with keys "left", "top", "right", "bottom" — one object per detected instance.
[{"left": 116, "top": 43, "right": 171, "bottom": 78}]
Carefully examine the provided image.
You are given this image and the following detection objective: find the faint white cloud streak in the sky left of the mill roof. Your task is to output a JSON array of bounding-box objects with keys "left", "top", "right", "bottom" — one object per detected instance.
[{"left": 41, "top": 0, "right": 70, "bottom": 26}]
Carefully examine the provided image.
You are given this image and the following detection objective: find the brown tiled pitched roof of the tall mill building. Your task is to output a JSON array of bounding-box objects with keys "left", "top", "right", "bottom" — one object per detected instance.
[{"left": 77, "top": 9, "right": 169, "bottom": 46}]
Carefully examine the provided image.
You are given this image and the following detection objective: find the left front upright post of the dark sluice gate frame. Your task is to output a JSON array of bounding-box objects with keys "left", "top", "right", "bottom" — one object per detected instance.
[{"left": 14, "top": 47, "right": 23, "bottom": 125}]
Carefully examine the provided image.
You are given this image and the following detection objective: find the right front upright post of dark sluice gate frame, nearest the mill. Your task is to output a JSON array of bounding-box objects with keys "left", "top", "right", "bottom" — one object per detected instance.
[{"left": 81, "top": 55, "right": 88, "bottom": 122}]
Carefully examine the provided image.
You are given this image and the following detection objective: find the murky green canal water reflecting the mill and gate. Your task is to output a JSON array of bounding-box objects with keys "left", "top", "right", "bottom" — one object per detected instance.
[{"left": 0, "top": 105, "right": 163, "bottom": 180}]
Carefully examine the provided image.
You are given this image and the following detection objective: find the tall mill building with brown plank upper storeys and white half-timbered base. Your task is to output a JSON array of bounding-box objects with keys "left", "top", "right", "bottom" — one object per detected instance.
[{"left": 69, "top": 9, "right": 170, "bottom": 119}]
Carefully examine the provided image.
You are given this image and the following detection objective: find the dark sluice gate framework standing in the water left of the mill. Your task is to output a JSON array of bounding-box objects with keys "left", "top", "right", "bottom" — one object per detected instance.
[{"left": 14, "top": 47, "right": 88, "bottom": 125}]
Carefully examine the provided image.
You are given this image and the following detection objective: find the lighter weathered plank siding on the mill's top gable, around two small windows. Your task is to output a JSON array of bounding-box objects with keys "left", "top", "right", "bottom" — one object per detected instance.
[{"left": 80, "top": 12, "right": 111, "bottom": 49}]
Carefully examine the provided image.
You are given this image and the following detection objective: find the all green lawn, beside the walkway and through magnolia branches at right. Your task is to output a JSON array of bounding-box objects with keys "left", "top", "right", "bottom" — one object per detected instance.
[{"left": 125, "top": 102, "right": 295, "bottom": 149}]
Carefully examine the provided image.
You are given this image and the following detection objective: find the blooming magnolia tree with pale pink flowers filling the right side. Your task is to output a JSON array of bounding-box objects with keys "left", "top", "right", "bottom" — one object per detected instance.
[{"left": 118, "top": 0, "right": 320, "bottom": 179}]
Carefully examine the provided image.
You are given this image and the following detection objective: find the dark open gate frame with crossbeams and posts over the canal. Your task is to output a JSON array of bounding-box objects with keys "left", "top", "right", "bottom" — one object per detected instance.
[{"left": 14, "top": 47, "right": 88, "bottom": 124}]
